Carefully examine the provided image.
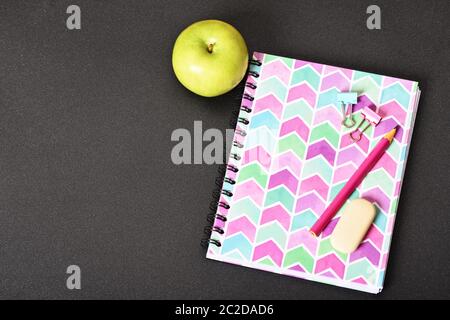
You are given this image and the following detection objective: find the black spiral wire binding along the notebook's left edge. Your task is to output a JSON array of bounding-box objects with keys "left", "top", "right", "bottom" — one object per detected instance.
[{"left": 201, "top": 59, "right": 262, "bottom": 248}]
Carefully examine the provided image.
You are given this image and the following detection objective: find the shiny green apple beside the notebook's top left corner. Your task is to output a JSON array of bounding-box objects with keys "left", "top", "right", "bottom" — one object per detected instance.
[{"left": 172, "top": 20, "right": 248, "bottom": 97}]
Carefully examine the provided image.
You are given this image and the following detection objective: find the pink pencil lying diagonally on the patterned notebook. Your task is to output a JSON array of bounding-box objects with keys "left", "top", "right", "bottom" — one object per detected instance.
[{"left": 309, "top": 128, "right": 397, "bottom": 236}]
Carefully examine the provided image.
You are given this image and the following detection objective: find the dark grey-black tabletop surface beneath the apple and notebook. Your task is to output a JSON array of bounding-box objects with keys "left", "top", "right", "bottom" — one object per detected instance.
[{"left": 0, "top": 0, "right": 450, "bottom": 299}]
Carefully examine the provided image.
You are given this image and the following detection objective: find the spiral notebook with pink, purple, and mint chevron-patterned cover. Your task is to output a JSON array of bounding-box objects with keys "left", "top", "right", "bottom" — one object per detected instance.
[{"left": 207, "top": 53, "right": 420, "bottom": 293}]
